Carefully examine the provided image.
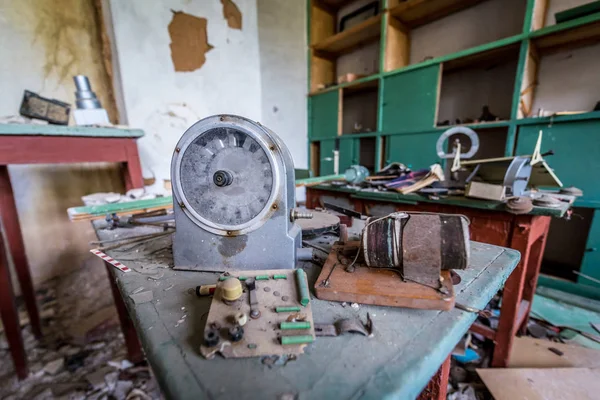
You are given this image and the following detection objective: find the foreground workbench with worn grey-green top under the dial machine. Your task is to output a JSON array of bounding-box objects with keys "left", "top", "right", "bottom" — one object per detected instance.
[{"left": 93, "top": 221, "right": 519, "bottom": 399}]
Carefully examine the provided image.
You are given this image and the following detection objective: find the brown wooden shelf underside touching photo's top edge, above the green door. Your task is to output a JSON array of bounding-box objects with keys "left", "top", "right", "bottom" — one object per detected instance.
[{"left": 390, "top": 0, "right": 485, "bottom": 28}]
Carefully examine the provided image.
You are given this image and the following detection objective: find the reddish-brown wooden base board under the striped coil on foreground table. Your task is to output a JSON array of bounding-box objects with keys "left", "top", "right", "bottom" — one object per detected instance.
[{"left": 315, "top": 242, "right": 455, "bottom": 311}]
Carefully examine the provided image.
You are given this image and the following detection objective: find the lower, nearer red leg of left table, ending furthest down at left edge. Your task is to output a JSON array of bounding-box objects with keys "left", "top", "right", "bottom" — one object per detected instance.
[{"left": 0, "top": 225, "right": 29, "bottom": 379}]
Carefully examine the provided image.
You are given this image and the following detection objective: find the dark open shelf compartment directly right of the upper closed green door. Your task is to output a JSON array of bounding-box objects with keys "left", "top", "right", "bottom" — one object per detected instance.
[{"left": 436, "top": 44, "right": 520, "bottom": 129}]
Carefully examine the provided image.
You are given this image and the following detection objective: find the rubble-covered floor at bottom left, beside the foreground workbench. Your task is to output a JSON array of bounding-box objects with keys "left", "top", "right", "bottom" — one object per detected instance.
[{"left": 0, "top": 259, "right": 160, "bottom": 400}]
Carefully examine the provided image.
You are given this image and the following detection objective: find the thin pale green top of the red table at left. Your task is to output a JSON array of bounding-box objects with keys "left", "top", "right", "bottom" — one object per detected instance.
[{"left": 0, "top": 124, "right": 144, "bottom": 138}]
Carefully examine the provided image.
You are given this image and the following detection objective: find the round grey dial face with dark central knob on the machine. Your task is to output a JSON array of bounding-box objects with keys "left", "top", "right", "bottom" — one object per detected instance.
[{"left": 179, "top": 127, "right": 274, "bottom": 229}]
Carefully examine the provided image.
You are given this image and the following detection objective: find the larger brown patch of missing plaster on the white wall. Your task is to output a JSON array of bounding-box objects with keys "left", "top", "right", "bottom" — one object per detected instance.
[{"left": 169, "top": 11, "right": 214, "bottom": 72}]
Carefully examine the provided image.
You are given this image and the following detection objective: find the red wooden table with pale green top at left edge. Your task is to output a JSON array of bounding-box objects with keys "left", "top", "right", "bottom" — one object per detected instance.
[{"left": 0, "top": 124, "right": 144, "bottom": 379}]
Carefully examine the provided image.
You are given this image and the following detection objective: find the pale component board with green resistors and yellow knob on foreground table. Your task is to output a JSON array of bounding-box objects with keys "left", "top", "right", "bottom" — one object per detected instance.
[{"left": 200, "top": 269, "right": 315, "bottom": 358}]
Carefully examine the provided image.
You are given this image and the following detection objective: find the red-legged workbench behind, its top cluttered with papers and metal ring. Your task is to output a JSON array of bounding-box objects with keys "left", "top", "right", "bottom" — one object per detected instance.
[{"left": 306, "top": 185, "right": 571, "bottom": 367}]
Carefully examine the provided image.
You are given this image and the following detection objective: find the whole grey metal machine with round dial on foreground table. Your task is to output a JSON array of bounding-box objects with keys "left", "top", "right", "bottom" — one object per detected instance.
[{"left": 171, "top": 115, "right": 301, "bottom": 271}]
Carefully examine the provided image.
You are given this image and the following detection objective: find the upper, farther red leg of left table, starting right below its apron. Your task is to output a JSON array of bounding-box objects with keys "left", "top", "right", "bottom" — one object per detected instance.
[{"left": 0, "top": 165, "right": 42, "bottom": 338}]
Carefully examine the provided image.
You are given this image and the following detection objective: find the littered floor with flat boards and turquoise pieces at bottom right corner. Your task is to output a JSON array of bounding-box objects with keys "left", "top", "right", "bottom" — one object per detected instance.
[{"left": 447, "top": 287, "right": 600, "bottom": 400}]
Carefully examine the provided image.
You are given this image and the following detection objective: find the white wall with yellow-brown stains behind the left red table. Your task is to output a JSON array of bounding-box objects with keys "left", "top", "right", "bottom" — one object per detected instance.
[{"left": 0, "top": 0, "right": 123, "bottom": 291}]
